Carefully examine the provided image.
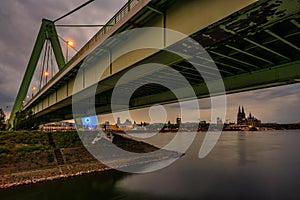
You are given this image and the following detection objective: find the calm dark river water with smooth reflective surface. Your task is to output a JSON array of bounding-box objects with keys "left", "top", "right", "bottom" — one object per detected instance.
[{"left": 0, "top": 130, "right": 300, "bottom": 200}]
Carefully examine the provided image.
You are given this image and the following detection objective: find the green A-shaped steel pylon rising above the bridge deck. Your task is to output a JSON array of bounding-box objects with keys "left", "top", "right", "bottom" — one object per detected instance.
[{"left": 8, "top": 19, "right": 65, "bottom": 129}]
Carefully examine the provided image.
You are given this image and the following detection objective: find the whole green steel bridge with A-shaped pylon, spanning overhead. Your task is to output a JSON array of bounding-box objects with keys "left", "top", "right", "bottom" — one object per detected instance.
[{"left": 9, "top": 0, "right": 300, "bottom": 127}]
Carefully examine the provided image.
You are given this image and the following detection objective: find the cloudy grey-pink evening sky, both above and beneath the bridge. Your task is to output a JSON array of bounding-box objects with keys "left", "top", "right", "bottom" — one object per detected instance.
[{"left": 0, "top": 0, "right": 300, "bottom": 123}]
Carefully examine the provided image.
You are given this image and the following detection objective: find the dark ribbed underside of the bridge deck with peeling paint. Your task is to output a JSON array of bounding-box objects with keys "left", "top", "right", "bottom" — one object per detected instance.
[{"left": 27, "top": 0, "right": 300, "bottom": 123}]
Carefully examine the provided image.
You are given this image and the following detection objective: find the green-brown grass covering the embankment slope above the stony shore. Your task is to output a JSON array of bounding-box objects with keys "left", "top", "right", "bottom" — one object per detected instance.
[{"left": 0, "top": 131, "right": 166, "bottom": 175}]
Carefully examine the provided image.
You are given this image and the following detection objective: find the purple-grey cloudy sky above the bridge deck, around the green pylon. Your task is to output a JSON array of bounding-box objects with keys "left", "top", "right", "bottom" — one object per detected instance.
[{"left": 0, "top": 0, "right": 127, "bottom": 113}]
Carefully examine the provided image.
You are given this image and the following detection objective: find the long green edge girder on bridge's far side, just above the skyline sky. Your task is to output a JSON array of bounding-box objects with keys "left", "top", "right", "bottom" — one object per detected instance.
[{"left": 132, "top": 61, "right": 300, "bottom": 108}]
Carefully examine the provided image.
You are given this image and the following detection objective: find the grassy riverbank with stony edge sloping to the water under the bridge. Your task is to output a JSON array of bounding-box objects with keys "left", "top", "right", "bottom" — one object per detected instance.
[{"left": 0, "top": 132, "right": 166, "bottom": 188}]
